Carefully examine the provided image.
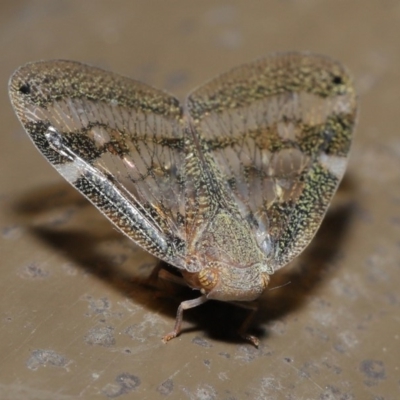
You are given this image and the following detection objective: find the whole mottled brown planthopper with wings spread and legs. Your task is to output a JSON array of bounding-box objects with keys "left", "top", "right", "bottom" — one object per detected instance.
[{"left": 9, "top": 53, "right": 357, "bottom": 346}]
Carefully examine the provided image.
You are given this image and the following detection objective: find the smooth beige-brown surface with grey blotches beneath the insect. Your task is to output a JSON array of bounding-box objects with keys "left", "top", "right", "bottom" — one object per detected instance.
[{"left": 0, "top": 0, "right": 400, "bottom": 400}]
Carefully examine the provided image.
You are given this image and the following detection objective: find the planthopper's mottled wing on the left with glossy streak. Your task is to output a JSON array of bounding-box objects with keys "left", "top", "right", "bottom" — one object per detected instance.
[{"left": 10, "top": 61, "right": 185, "bottom": 267}]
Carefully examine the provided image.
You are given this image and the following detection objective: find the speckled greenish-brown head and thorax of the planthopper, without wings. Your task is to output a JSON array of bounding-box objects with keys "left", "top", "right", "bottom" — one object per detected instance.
[{"left": 183, "top": 211, "right": 271, "bottom": 301}]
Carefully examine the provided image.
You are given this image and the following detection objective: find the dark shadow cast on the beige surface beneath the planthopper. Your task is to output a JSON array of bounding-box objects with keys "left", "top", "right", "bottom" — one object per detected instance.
[{"left": 14, "top": 177, "right": 355, "bottom": 343}]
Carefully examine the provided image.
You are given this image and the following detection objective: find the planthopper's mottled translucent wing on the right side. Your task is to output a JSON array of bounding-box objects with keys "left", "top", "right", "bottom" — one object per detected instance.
[{"left": 186, "top": 53, "right": 356, "bottom": 270}]
